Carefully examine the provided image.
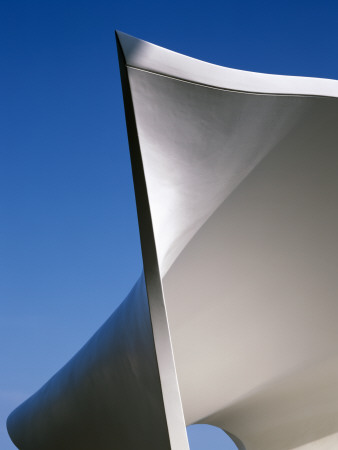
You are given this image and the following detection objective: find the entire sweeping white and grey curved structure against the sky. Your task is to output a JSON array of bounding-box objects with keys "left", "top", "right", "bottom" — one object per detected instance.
[{"left": 5, "top": 33, "right": 338, "bottom": 450}]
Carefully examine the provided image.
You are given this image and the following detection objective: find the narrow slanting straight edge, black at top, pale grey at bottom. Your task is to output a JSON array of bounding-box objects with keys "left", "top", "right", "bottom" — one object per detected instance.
[{"left": 116, "top": 36, "right": 189, "bottom": 450}]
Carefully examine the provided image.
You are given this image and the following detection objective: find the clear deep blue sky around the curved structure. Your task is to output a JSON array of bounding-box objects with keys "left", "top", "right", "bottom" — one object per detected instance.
[{"left": 0, "top": 0, "right": 338, "bottom": 450}]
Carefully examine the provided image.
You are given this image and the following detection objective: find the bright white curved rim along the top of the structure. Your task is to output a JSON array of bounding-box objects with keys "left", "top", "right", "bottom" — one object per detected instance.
[{"left": 116, "top": 31, "right": 338, "bottom": 97}]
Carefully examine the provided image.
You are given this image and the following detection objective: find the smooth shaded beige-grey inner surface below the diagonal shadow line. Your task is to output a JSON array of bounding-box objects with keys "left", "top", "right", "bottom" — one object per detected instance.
[{"left": 164, "top": 99, "right": 338, "bottom": 450}]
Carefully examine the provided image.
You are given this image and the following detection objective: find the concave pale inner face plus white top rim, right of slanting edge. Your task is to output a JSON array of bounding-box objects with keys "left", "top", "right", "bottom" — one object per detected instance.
[{"left": 119, "top": 33, "right": 338, "bottom": 450}]
